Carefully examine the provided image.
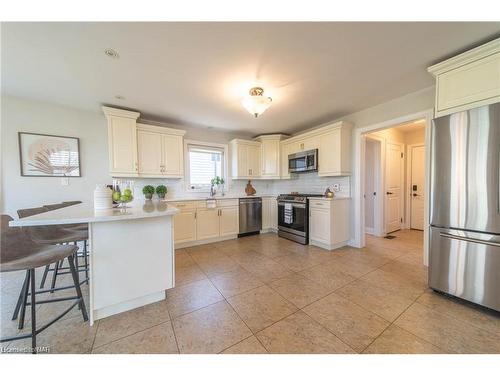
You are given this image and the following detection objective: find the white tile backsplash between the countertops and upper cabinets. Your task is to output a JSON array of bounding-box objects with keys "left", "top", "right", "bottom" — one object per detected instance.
[{"left": 127, "top": 173, "right": 350, "bottom": 199}]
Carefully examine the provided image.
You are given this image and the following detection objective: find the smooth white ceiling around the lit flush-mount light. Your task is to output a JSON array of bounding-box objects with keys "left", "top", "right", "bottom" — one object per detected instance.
[{"left": 1, "top": 22, "right": 500, "bottom": 134}]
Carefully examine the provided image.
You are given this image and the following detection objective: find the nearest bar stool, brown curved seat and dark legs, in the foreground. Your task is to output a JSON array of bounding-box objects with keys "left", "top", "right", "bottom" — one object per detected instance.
[{"left": 0, "top": 215, "right": 88, "bottom": 354}]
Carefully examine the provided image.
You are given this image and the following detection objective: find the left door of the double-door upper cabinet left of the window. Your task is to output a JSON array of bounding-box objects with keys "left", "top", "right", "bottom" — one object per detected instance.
[{"left": 137, "top": 130, "right": 162, "bottom": 175}]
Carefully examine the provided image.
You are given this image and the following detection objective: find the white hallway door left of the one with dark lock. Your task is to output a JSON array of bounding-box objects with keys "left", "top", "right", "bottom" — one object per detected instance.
[{"left": 384, "top": 142, "right": 403, "bottom": 233}]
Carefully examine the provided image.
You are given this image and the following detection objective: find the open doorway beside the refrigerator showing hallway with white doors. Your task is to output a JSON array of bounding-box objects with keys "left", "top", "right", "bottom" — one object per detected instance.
[{"left": 360, "top": 116, "right": 428, "bottom": 261}]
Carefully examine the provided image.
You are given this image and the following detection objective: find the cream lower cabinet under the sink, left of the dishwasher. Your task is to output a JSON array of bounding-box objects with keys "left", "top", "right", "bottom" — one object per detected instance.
[{"left": 172, "top": 199, "right": 239, "bottom": 249}]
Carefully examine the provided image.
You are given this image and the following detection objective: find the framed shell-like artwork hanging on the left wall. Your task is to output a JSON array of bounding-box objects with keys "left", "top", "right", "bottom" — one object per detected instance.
[{"left": 18, "top": 132, "right": 81, "bottom": 177}]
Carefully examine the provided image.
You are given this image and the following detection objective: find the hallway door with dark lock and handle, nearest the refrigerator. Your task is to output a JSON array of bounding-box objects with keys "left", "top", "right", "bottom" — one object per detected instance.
[{"left": 410, "top": 146, "right": 425, "bottom": 230}]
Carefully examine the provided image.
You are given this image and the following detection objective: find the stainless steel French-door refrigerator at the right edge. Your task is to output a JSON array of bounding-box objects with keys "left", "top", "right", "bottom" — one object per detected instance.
[{"left": 429, "top": 103, "right": 500, "bottom": 311}]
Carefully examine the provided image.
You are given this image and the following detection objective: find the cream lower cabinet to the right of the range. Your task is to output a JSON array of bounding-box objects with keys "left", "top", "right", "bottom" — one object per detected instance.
[{"left": 309, "top": 198, "right": 350, "bottom": 250}]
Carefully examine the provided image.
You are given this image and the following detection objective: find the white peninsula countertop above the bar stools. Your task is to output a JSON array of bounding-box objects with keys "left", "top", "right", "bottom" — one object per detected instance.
[{"left": 9, "top": 201, "right": 179, "bottom": 227}]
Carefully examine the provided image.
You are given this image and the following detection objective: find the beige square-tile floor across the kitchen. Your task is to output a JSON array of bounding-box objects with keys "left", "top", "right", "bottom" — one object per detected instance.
[{"left": 1, "top": 231, "right": 500, "bottom": 354}]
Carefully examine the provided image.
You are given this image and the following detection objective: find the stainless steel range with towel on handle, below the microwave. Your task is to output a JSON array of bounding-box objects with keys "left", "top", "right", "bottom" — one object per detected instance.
[{"left": 278, "top": 193, "right": 322, "bottom": 245}]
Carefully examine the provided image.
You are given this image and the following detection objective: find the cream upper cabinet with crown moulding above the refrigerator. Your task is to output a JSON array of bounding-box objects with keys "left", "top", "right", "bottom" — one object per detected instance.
[{"left": 428, "top": 39, "right": 500, "bottom": 117}]
